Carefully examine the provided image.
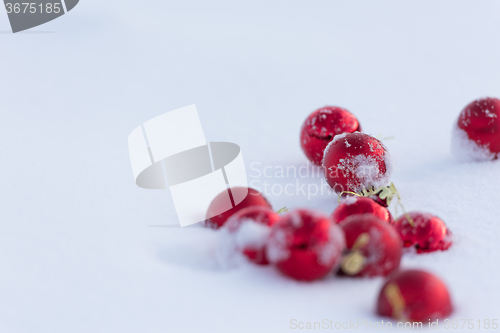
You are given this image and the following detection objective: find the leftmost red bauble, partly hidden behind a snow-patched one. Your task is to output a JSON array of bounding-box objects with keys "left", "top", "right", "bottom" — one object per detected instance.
[{"left": 205, "top": 187, "right": 272, "bottom": 229}]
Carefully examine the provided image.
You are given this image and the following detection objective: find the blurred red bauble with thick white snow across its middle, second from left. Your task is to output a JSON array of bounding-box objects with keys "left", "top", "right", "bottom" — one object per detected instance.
[{"left": 224, "top": 206, "right": 280, "bottom": 265}]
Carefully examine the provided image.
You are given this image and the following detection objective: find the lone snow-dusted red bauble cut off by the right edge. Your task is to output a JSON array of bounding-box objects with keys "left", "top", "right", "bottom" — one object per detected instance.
[{"left": 452, "top": 97, "right": 500, "bottom": 160}]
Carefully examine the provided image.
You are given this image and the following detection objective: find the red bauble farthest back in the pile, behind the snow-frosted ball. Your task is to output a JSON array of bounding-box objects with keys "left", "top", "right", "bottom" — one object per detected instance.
[{"left": 300, "top": 106, "right": 361, "bottom": 165}]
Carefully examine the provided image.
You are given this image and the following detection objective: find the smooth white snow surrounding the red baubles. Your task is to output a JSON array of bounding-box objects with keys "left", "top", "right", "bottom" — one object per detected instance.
[{"left": 0, "top": 0, "right": 500, "bottom": 333}]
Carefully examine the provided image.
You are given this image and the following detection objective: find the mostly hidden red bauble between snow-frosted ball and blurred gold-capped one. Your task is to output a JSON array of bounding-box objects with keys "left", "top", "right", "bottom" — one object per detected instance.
[{"left": 332, "top": 197, "right": 394, "bottom": 223}]
